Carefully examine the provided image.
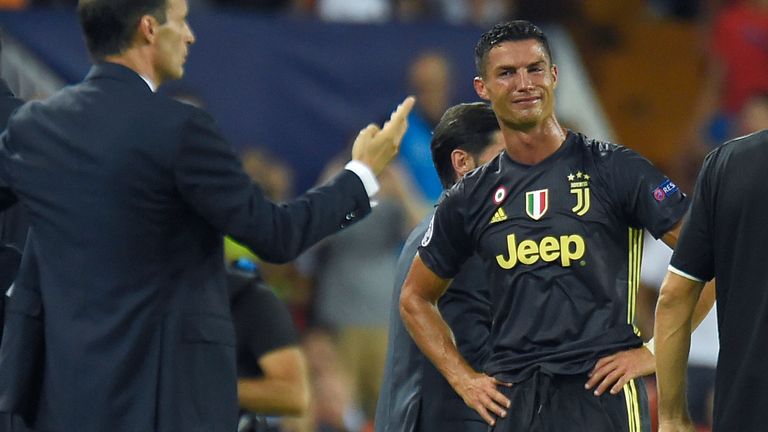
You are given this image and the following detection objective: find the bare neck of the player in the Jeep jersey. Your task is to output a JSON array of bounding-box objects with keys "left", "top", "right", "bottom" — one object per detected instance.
[{"left": 502, "top": 116, "right": 567, "bottom": 165}]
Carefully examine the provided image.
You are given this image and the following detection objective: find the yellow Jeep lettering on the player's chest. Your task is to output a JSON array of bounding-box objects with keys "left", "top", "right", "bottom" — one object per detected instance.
[{"left": 496, "top": 234, "right": 586, "bottom": 270}]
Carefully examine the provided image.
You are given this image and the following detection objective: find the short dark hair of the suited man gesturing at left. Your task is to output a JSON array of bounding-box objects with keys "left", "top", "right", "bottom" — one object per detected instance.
[{"left": 77, "top": 0, "right": 168, "bottom": 60}]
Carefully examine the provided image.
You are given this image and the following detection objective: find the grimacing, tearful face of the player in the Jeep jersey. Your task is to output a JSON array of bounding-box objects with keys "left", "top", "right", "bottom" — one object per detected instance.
[{"left": 475, "top": 39, "right": 557, "bottom": 131}]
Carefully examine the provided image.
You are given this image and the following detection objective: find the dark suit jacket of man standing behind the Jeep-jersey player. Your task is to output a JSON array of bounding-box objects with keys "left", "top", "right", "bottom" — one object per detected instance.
[{"left": 375, "top": 207, "right": 491, "bottom": 432}]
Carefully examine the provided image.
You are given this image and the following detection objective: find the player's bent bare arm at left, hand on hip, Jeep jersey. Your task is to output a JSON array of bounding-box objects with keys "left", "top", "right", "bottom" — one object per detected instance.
[{"left": 400, "top": 255, "right": 510, "bottom": 425}]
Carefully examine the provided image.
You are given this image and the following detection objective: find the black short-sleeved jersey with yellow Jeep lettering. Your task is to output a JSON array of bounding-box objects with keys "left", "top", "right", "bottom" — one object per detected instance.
[{"left": 419, "top": 132, "right": 687, "bottom": 381}]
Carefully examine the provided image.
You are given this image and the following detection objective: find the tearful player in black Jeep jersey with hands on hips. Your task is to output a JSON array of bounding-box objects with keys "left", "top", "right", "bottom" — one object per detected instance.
[{"left": 401, "top": 21, "right": 687, "bottom": 432}]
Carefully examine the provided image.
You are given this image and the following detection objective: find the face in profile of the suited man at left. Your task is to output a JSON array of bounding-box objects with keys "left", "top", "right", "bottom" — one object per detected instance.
[{"left": 155, "top": 0, "right": 195, "bottom": 84}]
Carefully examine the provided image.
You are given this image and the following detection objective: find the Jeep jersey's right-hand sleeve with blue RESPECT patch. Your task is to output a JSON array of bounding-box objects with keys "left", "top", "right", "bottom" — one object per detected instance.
[{"left": 611, "top": 147, "right": 689, "bottom": 239}]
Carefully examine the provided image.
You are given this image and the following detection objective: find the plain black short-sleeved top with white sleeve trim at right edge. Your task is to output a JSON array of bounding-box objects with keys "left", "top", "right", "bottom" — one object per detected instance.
[{"left": 669, "top": 130, "right": 768, "bottom": 431}]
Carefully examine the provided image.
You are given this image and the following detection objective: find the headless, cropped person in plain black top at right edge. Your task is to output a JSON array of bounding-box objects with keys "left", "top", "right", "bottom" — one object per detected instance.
[{"left": 655, "top": 130, "right": 768, "bottom": 432}]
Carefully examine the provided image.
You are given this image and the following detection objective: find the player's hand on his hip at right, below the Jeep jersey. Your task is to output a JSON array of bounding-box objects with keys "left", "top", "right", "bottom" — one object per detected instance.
[{"left": 584, "top": 347, "right": 656, "bottom": 396}]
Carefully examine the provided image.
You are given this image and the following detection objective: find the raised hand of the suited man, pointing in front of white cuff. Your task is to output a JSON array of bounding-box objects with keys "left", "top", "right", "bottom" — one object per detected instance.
[{"left": 352, "top": 96, "right": 416, "bottom": 175}]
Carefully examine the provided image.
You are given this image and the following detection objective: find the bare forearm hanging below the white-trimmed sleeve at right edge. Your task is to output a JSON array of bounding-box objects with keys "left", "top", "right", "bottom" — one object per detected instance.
[{"left": 654, "top": 272, "right": 704, "bottom": 432}]
